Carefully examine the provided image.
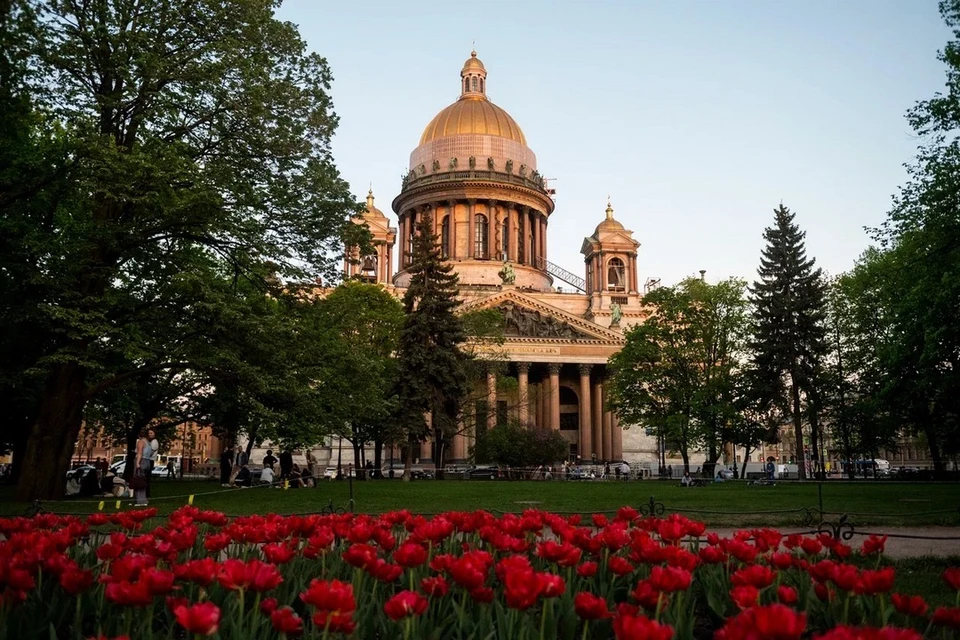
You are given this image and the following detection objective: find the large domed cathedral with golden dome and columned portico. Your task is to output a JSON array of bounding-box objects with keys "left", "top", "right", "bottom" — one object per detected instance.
[{"left": 331, "top": 52, "right": 657, "bottom": 468}]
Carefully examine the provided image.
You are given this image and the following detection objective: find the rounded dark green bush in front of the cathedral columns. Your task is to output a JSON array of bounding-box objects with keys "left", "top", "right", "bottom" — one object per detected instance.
[{"left": 473, "top": 423, "right": 570, "bottom": 468}]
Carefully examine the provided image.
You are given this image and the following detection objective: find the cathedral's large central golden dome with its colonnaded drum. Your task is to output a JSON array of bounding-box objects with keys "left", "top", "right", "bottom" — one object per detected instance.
[{"left": 393, "top": 51, "right": 554, "bottom": 291}]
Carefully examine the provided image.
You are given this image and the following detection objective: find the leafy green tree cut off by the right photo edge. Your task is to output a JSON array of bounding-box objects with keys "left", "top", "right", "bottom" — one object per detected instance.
[{"left": 864, "top": 0, "right": 960, "bottom": 474}]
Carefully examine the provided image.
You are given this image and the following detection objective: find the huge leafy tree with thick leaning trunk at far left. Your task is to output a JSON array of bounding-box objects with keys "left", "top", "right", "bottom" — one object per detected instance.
[{"left": 3, "top": 0, "right": 360, "bottom": 499}]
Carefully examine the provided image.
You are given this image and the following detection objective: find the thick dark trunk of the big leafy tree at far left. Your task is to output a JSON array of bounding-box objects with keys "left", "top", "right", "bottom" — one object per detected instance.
[{"left": 16, "top": 362, "right": 85, "bottom": 501}]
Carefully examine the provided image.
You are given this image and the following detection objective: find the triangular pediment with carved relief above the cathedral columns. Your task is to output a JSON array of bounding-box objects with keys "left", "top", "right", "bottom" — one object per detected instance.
[{"left": 461, "top": 291, "right": 623, "bottom": 342}]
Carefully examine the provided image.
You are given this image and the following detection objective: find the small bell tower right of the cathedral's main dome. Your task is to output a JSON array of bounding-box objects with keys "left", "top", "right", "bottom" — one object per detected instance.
[{"left": 580, "top": 200, "right": 641, "bottom": 324}]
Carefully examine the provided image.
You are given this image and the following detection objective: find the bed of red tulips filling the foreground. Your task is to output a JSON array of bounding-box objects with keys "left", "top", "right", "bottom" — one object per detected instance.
[{"left": 0, "top": 507, "right": 960, "bottom": 640}]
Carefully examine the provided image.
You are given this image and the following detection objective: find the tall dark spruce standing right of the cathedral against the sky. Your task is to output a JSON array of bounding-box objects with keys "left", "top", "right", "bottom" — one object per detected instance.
[{"left": 750, "top": 204, "right": 826, "bottom": 479}]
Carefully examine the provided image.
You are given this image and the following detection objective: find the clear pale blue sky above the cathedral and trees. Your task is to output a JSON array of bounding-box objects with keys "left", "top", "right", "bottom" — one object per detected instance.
[{"left": 280, "top": 0, "right": 950, "bottom": 284}]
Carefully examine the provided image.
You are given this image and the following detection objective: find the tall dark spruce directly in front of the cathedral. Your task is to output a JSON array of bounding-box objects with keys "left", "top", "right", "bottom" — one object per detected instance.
[{"left": 397, "top": 214, "right": 470, "bottom": 480}]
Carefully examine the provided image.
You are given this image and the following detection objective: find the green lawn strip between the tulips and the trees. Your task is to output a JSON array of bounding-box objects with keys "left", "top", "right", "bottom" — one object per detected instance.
[{"left": 0, "top": 480, "right": 960, "bottom": 526}]
